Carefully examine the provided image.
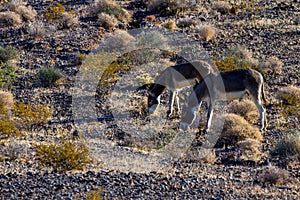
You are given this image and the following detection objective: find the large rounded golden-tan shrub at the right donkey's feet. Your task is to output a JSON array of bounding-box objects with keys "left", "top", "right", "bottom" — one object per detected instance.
[{"left": 219, "top": 113, "right": 263, "bottom": 145}]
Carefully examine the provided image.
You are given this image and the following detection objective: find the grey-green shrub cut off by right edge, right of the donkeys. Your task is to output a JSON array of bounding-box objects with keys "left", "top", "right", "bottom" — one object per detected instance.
[{"left": 271, "top": 131, "right": 300, "bottom": 157}]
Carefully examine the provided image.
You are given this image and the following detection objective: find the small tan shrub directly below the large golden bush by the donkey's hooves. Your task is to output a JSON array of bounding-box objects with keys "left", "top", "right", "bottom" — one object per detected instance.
[{"left": 237, "top": 138, "right": 262, "bottom": 161}]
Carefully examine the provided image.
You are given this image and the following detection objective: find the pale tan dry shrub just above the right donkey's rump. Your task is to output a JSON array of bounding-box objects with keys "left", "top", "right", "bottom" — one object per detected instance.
[{"left": 259, "top": 56, "right": 283, "bottom": 75}]
